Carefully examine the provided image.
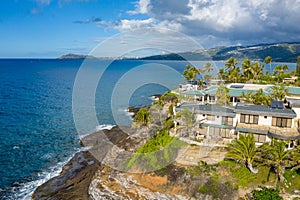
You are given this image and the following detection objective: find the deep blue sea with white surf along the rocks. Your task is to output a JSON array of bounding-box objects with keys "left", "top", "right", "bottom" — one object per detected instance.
[{"left": 0, "top": 59, "right": 295, "bottom": 199}]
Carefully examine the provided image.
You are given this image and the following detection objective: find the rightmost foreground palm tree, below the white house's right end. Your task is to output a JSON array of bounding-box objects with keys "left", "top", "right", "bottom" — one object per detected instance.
[{"left": 259, "top": 139, "right": 300, "bottom": 185}]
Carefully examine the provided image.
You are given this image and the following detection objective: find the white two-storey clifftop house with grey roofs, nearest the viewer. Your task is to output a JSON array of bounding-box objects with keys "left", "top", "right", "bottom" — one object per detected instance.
[{"left": 175, "top": 101, "right": 300, "bottom": 146}]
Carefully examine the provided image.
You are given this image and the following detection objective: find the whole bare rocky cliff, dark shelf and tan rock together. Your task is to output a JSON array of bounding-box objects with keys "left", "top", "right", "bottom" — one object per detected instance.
[{"left": 32, "top": 127, "right": 234, "bottom": 200}]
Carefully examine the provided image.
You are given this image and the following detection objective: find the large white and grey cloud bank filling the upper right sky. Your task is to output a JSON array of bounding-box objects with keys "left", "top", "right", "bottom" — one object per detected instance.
[{"left": 123, "top": 0, "right": 300, "bottom": 45}]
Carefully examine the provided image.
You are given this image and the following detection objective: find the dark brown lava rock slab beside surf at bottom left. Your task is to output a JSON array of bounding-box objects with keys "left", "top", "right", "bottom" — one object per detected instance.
[{"left": 32, "top": 151, "right": 100, "bottom": 200}]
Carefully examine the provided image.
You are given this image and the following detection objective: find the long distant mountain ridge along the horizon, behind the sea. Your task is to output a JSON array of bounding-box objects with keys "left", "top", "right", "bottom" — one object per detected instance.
[{"left": 58, "top": 42, "right": 300, "bottom": 62}]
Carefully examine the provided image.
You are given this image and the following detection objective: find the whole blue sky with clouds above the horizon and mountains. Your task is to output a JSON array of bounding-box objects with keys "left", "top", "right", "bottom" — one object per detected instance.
[{"left": 0, "top": 0, "right": 300, "bottom": 58}]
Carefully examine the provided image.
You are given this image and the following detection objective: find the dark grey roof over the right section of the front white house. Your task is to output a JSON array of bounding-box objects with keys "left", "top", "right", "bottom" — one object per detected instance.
[{"left": 234, "top": 103, "right": 296, "bottom": 118}]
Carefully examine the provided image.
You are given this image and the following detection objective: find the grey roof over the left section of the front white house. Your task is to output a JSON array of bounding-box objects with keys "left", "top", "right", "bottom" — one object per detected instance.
[{"left": 176, "top": 103, "right": 235, "bottom": 117}]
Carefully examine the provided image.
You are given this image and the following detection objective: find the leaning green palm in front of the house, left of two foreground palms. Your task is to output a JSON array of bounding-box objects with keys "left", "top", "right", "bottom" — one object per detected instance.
[{"left": 226, "top": 133, "right": 258, "bottom": 174}]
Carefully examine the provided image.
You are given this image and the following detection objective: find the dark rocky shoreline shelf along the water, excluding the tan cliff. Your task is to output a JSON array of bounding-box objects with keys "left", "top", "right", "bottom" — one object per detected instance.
[{"left": 32, "top": 126, "right": 150, "bottom": 199}]
